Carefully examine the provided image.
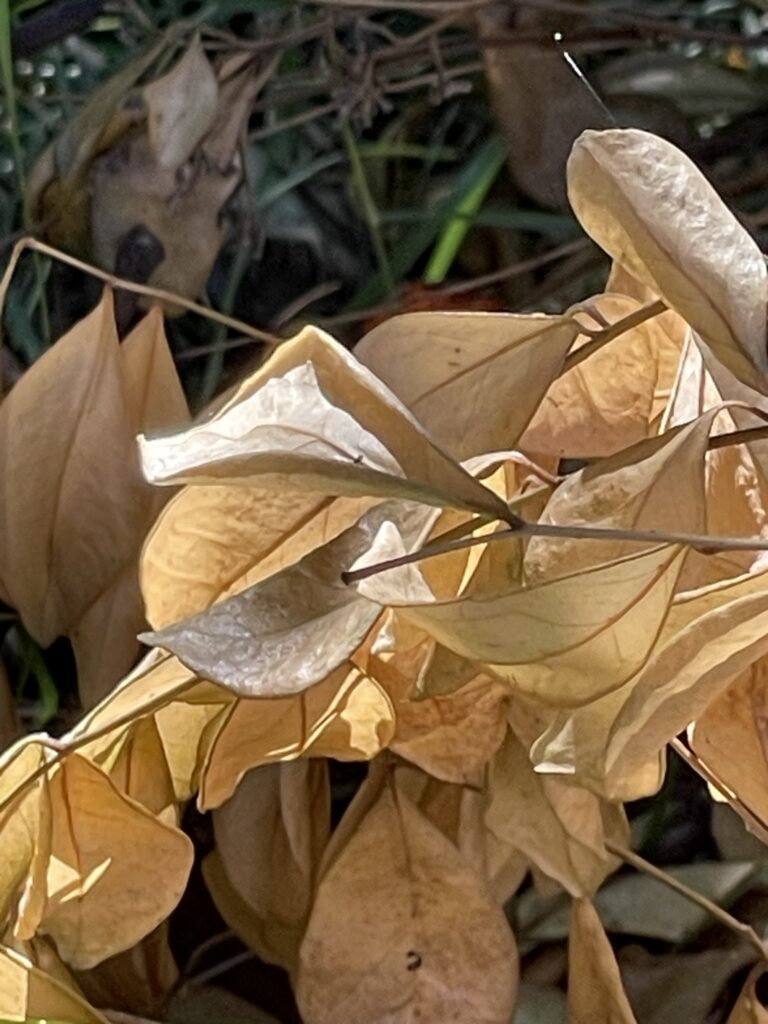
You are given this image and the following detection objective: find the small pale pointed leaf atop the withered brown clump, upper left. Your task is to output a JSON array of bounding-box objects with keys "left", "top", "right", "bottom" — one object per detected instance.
[{"left": 143, "top": 35, "right": 218, "bottom": 171}]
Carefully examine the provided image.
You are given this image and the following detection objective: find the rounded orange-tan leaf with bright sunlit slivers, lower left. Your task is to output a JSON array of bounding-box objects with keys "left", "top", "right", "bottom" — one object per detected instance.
[{"left": 41, "top": 754, "right": 193, "bottom": 969}]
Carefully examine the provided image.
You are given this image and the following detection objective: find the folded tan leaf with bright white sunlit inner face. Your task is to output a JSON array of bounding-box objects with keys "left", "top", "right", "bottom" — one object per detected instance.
[{"left": 139, "top": 328, "right": 506, "bottom": 517}]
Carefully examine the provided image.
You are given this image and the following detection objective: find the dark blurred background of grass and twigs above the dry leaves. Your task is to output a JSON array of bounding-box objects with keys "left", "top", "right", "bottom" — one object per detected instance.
[{"left": 0, "top": 0, "right": 768, "bottom": 408}]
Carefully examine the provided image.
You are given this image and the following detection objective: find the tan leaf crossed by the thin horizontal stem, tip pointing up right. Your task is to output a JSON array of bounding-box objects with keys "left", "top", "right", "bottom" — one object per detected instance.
[{"left": 523, "top": 410, "right": 717, "bottom": 584}]
